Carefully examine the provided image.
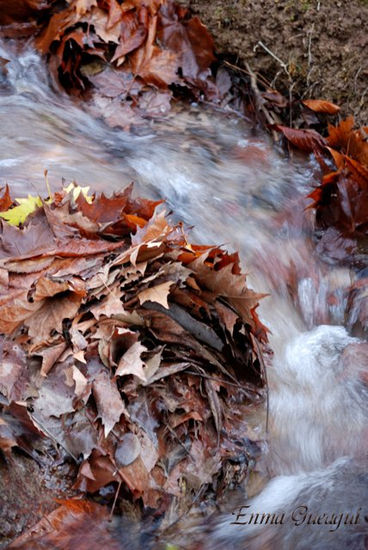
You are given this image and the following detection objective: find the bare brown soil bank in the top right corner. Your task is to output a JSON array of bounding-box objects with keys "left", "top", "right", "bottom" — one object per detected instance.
[{"left": 182, "top": 0, "right": 368, "bottom": 124}]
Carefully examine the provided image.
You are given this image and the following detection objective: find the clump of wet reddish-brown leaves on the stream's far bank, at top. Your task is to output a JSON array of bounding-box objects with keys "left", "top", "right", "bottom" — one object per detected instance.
[{"left": 31, "top": 0, "right": 218, "bottom": 127}]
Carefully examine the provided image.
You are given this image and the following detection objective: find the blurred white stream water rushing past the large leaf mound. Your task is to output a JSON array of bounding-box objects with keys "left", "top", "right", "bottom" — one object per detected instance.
[{"left": 0, "top": 38, "right": 368, "bottom": 550}]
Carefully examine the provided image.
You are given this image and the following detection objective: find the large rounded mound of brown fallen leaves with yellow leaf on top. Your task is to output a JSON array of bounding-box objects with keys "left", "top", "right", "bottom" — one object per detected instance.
[{"left": 0, "top": 186, "right": 267, "bottom": 532}]
